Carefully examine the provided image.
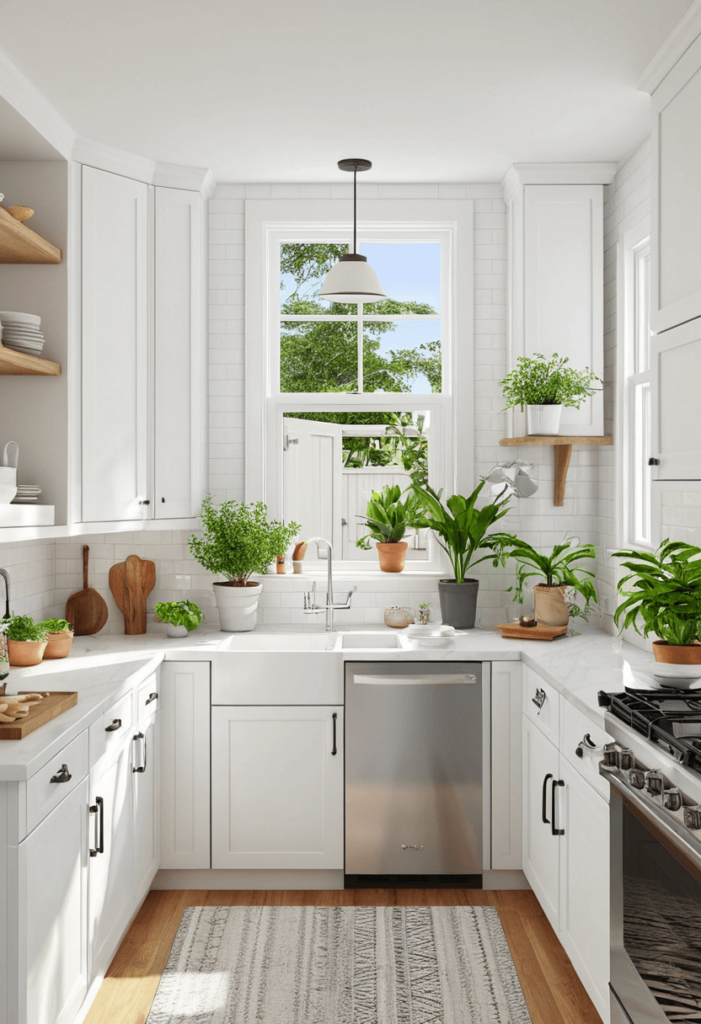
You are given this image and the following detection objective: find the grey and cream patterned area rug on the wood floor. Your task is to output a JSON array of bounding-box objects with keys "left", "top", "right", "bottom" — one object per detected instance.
[{"left": 147, "top": 906, "right": 530, "bottom": 1024}]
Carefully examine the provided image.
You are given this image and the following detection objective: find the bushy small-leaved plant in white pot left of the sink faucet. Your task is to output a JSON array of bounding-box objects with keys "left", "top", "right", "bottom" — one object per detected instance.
[{"left": 189, "top": 495, "right": 300, "bottom": 633}]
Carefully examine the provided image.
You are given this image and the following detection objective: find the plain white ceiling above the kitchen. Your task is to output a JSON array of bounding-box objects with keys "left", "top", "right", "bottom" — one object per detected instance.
[{"left": 0, "top": 0, "right": 691, "bottom": 182}]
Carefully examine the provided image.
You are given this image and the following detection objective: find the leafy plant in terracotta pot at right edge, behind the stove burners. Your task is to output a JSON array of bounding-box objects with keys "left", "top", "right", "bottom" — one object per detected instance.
[{"left": 613, "top": 539, "right": 701, "bottom": 665}]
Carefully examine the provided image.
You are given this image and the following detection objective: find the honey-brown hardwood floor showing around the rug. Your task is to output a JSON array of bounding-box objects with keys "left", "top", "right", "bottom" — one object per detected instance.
[{"left": 85, "top": 889, "right": 601, "bottom": 1024}]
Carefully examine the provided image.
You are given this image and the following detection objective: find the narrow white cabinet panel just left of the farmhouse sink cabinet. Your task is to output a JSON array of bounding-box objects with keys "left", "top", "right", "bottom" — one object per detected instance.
[{"left": 159, "top": 662, "right": 212, "bottom": 868}]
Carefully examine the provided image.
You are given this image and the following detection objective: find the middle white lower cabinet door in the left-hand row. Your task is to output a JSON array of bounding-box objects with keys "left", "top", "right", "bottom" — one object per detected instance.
[{"left": 88, "top": 738, "right": 133, "bottom": 978}]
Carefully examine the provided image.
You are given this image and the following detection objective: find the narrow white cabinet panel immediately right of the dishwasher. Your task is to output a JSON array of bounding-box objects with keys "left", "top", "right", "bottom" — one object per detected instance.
[{"left": 491, "top": 662, "right": 523, "bottom": 871}]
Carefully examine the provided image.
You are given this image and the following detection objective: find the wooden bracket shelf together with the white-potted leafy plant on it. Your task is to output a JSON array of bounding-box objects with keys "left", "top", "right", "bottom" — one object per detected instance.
[{"left": 499, "top": 352, "right": 613, "bottom": 506}]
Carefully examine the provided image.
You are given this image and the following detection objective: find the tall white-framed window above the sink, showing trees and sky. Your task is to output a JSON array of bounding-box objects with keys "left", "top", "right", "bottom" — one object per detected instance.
[{"left": 246, "top": 201, "right": 473, "bottom": 570}]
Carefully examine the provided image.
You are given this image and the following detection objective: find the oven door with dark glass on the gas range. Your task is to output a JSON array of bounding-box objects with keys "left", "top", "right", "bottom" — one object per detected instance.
[{"left": 609, "top": 774, "right": 701, "bottom": 1024}]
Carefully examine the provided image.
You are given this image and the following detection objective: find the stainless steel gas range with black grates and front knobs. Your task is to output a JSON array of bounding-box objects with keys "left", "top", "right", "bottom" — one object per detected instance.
[{"left": 599, "top": 689, "right": 701, "bottom": 1024}]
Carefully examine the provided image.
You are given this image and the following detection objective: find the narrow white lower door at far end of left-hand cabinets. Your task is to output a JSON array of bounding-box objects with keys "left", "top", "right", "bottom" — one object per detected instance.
[{"left": 131, "top": 714, "right": 161, "bottom": 902}]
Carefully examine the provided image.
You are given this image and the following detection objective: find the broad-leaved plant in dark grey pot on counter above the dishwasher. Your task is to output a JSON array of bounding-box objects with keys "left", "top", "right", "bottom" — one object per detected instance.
[{"left": 413, "top": 481, "right": 512, "bottom": 630}]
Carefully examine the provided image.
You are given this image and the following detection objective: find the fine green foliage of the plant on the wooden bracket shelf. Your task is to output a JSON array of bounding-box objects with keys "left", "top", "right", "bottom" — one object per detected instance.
[{"left": 499, "top": 352, "right": 602, "bottom": 412}]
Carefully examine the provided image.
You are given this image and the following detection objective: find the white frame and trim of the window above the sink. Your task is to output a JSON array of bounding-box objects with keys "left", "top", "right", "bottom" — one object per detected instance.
[{"left": 245, "top": 200, "right": 474, "bottom": 572}]
